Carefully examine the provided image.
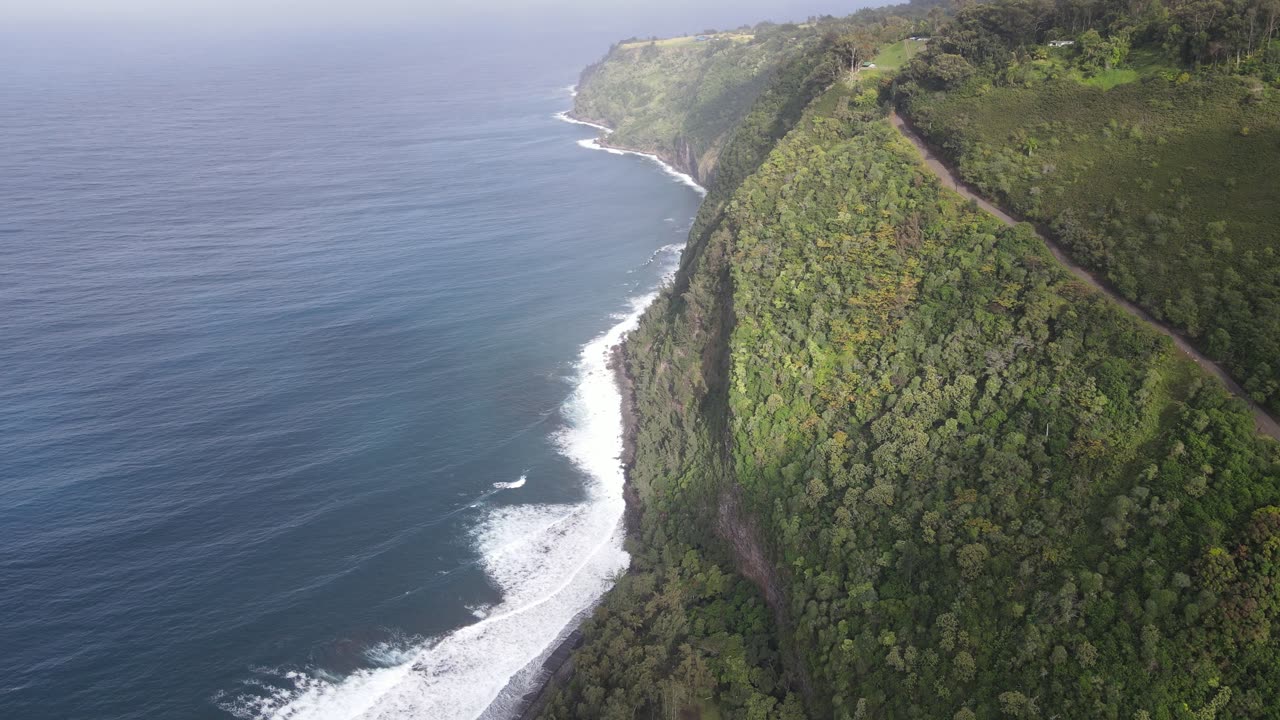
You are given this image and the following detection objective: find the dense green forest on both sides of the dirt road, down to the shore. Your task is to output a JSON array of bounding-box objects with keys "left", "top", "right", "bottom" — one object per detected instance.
[{"left": 543, "top": 0, "right": 1280, "bottom": 720}]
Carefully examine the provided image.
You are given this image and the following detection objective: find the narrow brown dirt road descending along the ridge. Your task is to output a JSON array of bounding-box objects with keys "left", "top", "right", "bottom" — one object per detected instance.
[{"left": 890, "top": 113, "right": 1280, "bottom": 441}]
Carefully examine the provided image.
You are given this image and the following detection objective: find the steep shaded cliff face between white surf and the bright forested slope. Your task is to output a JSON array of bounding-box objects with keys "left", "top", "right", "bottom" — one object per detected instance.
[{"left": 544, "top": 41, "right": 829, "bottom": 717}]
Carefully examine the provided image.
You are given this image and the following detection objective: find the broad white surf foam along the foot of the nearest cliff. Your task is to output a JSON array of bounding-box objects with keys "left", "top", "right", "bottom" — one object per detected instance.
[{"left": 230, "top": 356, "right": 639, "bottom": 720}]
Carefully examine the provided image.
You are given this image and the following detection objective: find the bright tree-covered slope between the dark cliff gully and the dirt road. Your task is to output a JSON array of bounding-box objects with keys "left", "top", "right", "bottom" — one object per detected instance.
[{"left": 730, "top": 87, "right": 1280, "bottom": 717}]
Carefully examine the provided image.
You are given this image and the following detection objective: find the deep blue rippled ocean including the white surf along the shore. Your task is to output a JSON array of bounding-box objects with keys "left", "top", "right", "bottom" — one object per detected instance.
[{"left": 0, "top": 33, "right": 699, "bottom": 720}]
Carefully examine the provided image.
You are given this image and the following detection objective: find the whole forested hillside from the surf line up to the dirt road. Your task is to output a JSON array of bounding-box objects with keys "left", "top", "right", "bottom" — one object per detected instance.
[{"left": 544, "top": 1, "right": 1280, "bottom": 719}]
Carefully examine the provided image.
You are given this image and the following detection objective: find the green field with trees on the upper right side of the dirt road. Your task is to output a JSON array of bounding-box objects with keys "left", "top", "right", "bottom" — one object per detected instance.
[{"left": 897, "top": 0, "right": 1280, "bottom": 410}]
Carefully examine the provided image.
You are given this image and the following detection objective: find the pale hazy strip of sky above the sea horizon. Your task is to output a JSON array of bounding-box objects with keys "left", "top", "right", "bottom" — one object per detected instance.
[{"left": 0, "top": 0, "right": 882, "bottom": 35}]
